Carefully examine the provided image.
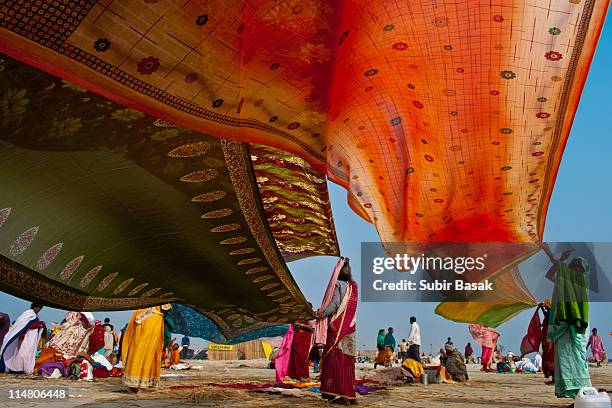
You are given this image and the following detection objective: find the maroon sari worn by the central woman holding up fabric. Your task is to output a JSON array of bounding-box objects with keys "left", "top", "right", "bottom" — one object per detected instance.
[{"left": 321, "top": 281, "right": 358, "bottom": 399}]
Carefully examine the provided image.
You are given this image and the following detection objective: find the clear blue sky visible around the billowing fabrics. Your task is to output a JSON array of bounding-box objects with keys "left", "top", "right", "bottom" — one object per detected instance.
[{"left": 0, "top": 19, "right": 612, "bottom": 352}]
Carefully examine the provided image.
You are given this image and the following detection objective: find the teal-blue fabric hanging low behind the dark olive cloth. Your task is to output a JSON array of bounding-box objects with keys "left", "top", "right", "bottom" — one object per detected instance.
[{"left": 166, "top": 303, "right": 288, "bottom": 344}]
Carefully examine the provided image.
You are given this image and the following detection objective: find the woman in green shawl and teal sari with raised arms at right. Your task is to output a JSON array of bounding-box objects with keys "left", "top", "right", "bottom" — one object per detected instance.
[{"left": 544, "top": 246, "right": 591, "bottom": 398}]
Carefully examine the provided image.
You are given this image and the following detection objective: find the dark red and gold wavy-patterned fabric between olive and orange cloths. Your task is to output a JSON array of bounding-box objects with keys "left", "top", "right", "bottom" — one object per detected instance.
[{"left": 249, "top": 144, "right": 340, "bottom": 261}]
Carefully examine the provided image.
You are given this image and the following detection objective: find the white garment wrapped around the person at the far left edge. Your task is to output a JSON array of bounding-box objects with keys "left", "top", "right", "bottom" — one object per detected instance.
[{"left": 0, "top": 309, "right": 43, "bottom": 374}]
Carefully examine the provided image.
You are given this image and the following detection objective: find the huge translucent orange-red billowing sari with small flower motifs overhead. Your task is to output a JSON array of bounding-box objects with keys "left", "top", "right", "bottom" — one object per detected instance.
[{"left": 0, "top": 0, "right": 608, "bottom": 255}]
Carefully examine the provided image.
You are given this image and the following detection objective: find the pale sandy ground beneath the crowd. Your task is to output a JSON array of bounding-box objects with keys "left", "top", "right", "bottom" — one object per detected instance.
[{"left": 0, "top": 360, "right": 612, "bottom": 408}]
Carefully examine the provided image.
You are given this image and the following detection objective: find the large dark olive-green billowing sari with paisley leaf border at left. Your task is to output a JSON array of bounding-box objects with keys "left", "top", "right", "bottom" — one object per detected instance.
[{"left": 0, "top": 55, "right": 313, "bottom": 338}]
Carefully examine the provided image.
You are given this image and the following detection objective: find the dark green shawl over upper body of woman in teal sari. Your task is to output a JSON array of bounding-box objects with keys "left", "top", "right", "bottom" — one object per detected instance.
[{"left": 549, "top": 258, "right": 589, "bottom": 336}]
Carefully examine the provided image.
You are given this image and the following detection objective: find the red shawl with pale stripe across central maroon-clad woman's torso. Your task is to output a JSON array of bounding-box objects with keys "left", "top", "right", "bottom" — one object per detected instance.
[{"left": 323, "top": 281, "right": 359, "bottom": 359}]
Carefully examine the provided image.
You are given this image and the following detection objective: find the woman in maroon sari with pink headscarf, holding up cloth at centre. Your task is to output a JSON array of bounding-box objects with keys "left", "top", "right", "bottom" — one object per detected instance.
[{"left": 317, "top": 258, "right": 358, "bottom": 405}]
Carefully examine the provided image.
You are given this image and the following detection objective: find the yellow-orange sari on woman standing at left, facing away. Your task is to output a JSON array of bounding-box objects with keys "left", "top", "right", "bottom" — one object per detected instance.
[{"left": 121, "top": 306, "right": 164, "bottom": 388}]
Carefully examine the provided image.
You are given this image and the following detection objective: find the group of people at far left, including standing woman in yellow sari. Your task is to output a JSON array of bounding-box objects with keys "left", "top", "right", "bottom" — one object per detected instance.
[{"left": 0, "top": 303, "right": 182, "bottom": 391}]
